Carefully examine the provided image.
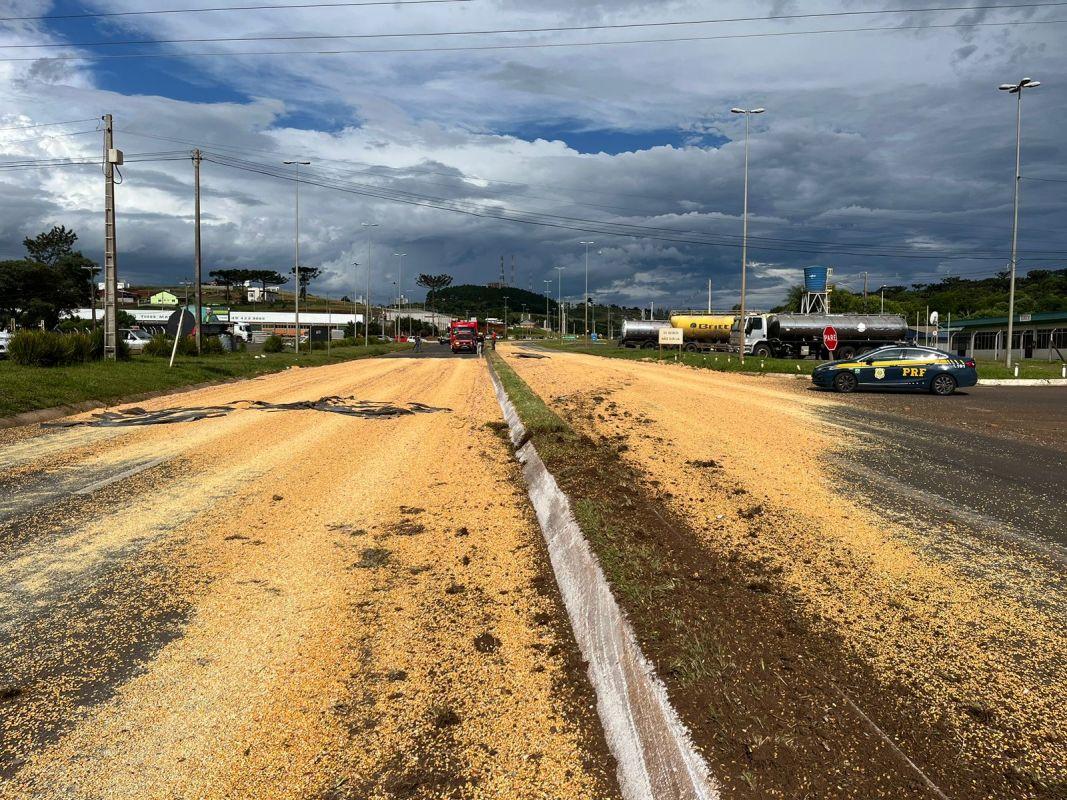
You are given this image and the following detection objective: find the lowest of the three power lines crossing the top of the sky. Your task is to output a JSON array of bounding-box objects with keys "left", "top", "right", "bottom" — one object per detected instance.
[{"left": 0, "top": 19, "right": 1067, "bottom": 62}]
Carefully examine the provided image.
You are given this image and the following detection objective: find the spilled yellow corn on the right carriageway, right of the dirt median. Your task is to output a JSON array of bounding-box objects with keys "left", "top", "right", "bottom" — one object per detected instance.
[{"left": 504, "top": 349, "right": 1067, "bottom": 797}]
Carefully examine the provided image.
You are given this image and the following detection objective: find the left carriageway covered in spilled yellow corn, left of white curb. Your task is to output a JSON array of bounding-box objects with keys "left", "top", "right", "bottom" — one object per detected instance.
[{"left": 0, "top": 359, "right": 617, "bottom": 798}]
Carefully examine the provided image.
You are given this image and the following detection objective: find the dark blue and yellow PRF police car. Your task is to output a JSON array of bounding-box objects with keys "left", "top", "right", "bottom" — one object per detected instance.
[{"left": 811, "top": 346, "right": 978, "bottom": 396}]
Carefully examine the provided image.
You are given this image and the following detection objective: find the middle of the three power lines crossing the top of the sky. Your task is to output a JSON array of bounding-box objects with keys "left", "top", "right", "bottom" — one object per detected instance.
[{"left": 0, "top": 0, "right": 1067, "bottom": 49}]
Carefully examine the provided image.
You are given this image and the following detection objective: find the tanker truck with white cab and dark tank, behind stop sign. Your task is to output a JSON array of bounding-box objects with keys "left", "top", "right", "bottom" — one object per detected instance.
[{"left": 730, "top": 314, "right": 908, "bottom": 359}]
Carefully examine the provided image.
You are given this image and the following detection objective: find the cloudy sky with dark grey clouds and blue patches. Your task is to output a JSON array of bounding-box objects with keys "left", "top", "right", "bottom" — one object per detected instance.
[{"left": 0, "top": 0, "right": 1067, "bottom": 307}]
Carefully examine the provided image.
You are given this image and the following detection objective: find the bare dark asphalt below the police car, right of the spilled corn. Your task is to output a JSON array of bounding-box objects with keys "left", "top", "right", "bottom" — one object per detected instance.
[{"left": 821, "top": 386, "right": 1067, "bottom": 550}]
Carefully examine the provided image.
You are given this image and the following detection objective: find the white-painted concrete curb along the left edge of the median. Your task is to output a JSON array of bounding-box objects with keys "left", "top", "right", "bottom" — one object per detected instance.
[{"left": 489, "top": 363, "right": 719, "bottom": 800}]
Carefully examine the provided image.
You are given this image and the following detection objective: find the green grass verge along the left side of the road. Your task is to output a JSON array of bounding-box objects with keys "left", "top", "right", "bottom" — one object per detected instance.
[{"left": 0, "top": 345, "right": 409, "bottom": 416}]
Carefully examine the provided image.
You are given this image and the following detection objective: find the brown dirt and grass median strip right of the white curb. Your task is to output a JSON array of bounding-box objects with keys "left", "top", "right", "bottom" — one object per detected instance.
[{"left": 490, "top": 354, "right": 1002, "bottom": 798}]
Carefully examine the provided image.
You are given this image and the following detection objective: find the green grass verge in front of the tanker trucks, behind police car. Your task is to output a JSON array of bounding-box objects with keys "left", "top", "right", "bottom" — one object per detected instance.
[{"left": 529, "top": 339, "right": 1063, "bottom": 379}]
